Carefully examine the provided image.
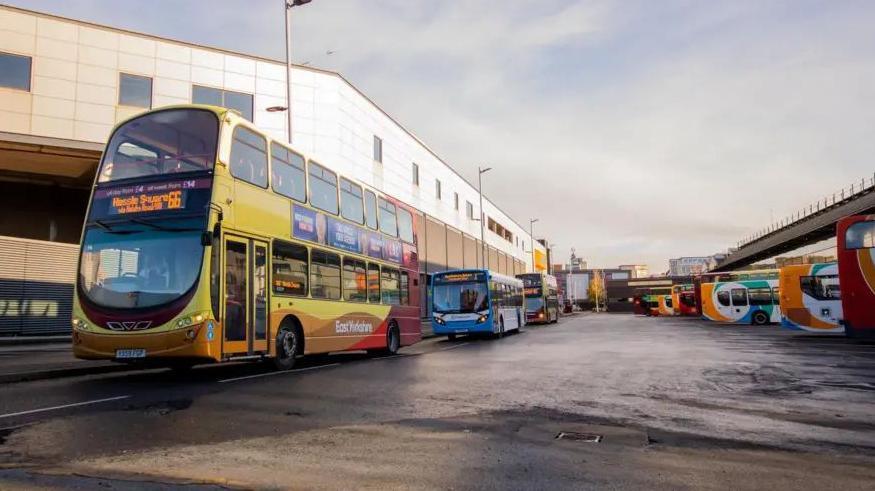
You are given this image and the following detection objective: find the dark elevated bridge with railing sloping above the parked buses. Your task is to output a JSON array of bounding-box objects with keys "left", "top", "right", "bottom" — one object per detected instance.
[{"left": 713, "top": 176, "right": 875, "bottom": 271}]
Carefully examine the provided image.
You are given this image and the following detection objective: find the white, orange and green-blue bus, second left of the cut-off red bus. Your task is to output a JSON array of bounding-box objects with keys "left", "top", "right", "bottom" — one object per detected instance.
[{"left": 700, "top": 270, "right": 781, "bottom": 325}]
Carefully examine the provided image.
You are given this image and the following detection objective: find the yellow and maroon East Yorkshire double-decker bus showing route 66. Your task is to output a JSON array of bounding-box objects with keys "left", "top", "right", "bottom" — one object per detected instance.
[{"left": 72, "top": 105, "right": 421, "bottom": 369}]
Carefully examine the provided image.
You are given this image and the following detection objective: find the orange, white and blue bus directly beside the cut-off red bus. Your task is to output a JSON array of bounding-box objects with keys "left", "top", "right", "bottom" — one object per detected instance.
[{"left": 778, "top": 263, "right": 845, "bottom": 333}]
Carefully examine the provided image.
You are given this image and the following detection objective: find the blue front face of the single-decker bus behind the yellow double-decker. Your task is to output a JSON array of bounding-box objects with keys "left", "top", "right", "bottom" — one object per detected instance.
[{"left": 431, "top": 270, "right": 494, "bottom": 339}]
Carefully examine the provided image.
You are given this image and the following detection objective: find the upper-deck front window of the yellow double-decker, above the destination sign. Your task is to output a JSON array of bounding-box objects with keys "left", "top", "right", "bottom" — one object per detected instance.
[{"left": 98, "top": 109, "right": 219, "bottom": 183}]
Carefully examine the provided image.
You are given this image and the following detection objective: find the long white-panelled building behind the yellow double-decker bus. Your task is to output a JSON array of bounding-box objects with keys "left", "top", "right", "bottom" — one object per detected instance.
[{"left": 0, "top": 6, "right": 546, "bottom": 335}]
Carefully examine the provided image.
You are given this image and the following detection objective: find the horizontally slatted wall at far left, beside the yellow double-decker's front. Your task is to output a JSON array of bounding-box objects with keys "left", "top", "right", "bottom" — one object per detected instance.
[{"left": 0, "top": 237, "right": 79, "bottom": 335}]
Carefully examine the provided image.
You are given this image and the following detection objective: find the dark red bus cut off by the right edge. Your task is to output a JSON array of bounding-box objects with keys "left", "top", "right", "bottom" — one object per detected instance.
[{"left": 836, "top": 215, "right": 875, "bottom": 337}]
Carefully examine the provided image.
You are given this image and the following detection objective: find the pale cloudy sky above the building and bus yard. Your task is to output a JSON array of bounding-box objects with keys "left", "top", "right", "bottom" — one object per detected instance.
[{"left": 10, "top": 0, "right": 875, "bottom": 272}]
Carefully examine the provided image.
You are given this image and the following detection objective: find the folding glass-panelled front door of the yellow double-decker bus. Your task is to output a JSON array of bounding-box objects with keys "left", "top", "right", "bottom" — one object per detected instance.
[{"left": 222, "top": 236, "right": 268, "bottom": 356}]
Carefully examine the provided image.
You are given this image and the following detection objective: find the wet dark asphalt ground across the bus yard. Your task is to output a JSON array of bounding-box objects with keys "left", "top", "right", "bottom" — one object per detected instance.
[{"left": 0, "top": 314, "right": 875, "bottom": 489}]
